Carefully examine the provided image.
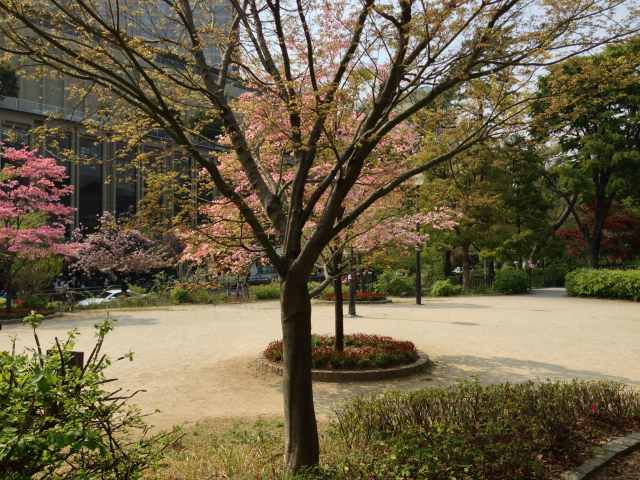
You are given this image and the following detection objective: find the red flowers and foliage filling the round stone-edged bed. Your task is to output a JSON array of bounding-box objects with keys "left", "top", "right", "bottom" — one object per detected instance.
[{"left": 264, "top": 333, "right": 419, "bottom": 370}]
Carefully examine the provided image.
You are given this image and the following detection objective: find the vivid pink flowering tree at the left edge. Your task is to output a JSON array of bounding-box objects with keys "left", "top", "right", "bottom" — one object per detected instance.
[{"left": 0, "top": 148, "right": 76, "bottom": 310}]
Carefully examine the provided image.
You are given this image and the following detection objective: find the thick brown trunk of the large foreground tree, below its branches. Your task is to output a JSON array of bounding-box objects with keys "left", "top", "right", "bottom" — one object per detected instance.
[{"left": 280, "top": 275, "right": 320, "bottom": 472}]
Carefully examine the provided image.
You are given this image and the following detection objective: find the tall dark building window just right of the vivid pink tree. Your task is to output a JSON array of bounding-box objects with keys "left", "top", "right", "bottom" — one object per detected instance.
[{"left": 77, "top": 137, "right": 104, "bottom": 231}]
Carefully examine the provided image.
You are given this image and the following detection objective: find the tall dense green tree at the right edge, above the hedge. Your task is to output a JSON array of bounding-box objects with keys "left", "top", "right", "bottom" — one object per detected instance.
[{"left": 533, "top": 39, "right": 640, "bottom": 267}]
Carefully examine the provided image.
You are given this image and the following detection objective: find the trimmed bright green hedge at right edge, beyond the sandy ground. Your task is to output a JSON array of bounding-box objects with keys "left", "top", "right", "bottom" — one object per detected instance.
[{"left": 565, "top": 268, "right": 640, "bottom": 302}]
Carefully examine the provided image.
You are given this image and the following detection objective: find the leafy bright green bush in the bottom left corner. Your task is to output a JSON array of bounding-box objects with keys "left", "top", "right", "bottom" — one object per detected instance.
[{"left": 0, "top": 315, "right": 175, "bottom": 480}]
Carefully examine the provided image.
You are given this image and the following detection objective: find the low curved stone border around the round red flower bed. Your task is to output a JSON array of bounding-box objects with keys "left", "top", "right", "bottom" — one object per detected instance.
[{"left": 258, "top": 352, "right": 431, "bottom": 383}]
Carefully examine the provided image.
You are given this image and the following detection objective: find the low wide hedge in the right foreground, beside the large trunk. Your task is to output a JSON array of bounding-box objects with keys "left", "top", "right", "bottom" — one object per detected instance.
[{"left": 323, "top": 382, "right": 640, "bottom": 480}]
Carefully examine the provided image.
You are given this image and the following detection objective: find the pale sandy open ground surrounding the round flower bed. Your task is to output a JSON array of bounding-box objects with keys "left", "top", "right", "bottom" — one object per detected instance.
[{"left": 0, "top": 289, "right": 640, "bottom": 427}]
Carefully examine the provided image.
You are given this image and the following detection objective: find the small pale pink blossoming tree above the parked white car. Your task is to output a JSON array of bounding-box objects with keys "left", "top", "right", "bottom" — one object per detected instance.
[{"left": 71, "top": 213, "right": 171, "bottom": 286}]
